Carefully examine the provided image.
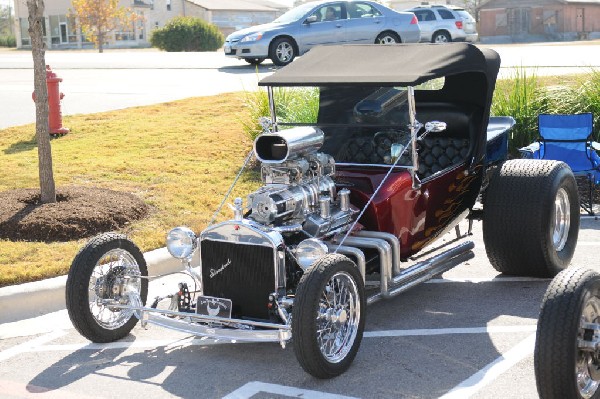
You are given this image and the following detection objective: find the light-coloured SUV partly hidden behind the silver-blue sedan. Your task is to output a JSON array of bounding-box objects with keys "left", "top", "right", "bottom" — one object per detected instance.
[{"left": 405, "top": 5, "right": 478, "bottom": 43}]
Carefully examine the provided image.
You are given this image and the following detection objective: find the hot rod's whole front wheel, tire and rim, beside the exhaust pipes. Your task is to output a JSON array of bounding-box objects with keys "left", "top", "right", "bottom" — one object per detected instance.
[{"left": 292, "top": 254, "right": 366, "bottom": 378}]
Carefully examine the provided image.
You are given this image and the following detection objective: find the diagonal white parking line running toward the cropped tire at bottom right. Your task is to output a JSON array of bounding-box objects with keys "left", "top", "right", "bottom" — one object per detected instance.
[{"left": 439, "top": 334, "right": 535, "bottom": 399}]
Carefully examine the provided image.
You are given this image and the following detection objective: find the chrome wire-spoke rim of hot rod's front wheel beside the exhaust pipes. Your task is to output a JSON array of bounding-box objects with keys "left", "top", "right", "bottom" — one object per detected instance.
[{"left": 317, "top": 272, "right": 361, "bottom": 363}]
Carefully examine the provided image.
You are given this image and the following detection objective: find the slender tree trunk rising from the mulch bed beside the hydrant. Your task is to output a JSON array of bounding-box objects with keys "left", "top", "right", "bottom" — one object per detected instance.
[{"left": 27, "top": 0, "right": 56, "bottom": 204}]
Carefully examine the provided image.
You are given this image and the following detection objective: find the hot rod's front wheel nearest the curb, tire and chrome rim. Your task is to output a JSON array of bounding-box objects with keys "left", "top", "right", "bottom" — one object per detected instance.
[{"left": 66, "top": 233, "right": 148, "bottom": 342}]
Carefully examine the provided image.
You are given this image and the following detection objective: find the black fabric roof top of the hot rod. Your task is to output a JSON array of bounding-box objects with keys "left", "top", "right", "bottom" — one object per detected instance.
[{"left": 259, "top": 43, "right": 500, "bottom": 86}]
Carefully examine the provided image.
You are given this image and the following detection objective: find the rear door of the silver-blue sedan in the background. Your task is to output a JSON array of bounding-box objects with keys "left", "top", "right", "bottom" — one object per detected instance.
[{"left": 346, "top": 2, "right": 385, "bottom": 44}]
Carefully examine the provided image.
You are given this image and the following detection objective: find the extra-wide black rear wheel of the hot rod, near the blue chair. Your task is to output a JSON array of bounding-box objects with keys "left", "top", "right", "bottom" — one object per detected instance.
[{"left": 483, "top": 159, "right": 579, "bottom": 277}]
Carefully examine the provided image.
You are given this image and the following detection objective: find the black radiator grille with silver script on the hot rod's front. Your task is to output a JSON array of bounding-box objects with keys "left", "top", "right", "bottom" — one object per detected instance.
[{"left": 200, "top": 240, "right": 275, "bottom": 319}]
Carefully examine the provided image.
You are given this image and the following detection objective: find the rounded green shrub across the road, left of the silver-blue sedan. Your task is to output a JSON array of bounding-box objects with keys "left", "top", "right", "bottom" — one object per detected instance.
[{"left": 150, "top": 17, "right": 225, "bottom": 51}]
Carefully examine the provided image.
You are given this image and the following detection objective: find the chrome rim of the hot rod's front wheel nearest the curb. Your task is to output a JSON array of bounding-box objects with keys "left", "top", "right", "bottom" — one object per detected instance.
[{"left": 88, "top": 248, "right": 142, "bottom": 330}]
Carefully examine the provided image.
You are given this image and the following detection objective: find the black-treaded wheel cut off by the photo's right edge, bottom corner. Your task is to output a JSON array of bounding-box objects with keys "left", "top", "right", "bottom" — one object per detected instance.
[{"left": 534, "top": 268, "right": 600, "bottom": 399}]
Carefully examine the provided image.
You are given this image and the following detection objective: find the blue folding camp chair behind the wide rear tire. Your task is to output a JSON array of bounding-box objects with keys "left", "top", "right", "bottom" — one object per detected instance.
[{"left": 519, "top": 113, "right": 600, "bottom": 215}]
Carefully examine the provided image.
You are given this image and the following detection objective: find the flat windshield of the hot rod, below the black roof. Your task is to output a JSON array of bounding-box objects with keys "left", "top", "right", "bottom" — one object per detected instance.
[{"left": 273, "top": 86, "right": 411, "bottom": 166}]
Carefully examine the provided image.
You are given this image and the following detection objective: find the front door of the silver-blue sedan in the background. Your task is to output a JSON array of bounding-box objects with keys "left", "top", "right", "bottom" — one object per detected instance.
[{"left": 296, "top": 2, "right": 347, "bottom": 51}]
